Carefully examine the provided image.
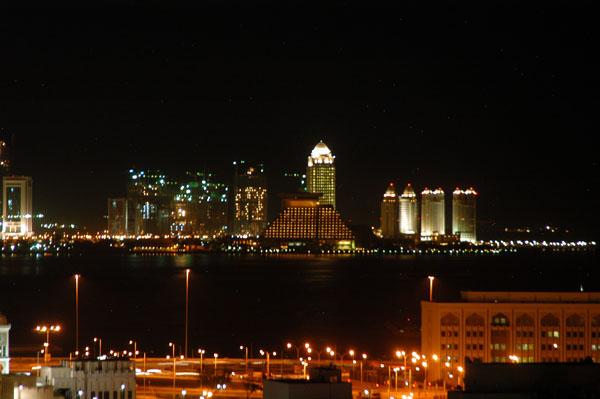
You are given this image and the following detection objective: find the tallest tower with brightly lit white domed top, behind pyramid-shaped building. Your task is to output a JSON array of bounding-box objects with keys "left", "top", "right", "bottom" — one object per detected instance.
[{"left": 306, "top": 141, "right": 336, "bottom": 209}]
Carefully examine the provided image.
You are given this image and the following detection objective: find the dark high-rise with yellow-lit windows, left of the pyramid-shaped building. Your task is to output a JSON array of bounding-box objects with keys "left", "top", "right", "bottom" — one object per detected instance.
[{"left": 232, "top": 161, "right": 267, "bottom": 236}]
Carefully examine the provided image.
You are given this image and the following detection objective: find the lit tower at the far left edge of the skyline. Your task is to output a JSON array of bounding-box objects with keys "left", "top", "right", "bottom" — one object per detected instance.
[{"left": 2, "top": 176, "right": 33, "bottom": 237}]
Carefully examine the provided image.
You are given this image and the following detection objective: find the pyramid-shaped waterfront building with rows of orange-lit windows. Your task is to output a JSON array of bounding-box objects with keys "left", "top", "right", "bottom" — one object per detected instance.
[{"left": 263, "top": 193, "right": 354, "bottom": 249}]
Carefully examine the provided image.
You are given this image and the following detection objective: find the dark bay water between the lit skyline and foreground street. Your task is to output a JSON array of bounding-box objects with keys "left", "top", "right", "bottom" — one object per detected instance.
[{"left": 0, "top": 254, "right": 600, "bottom": 356}]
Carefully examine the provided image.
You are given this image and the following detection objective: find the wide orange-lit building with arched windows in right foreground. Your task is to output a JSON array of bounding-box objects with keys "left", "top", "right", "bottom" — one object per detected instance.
[{"left": 421, "top": 291, "right": 600, "bottom": 379}]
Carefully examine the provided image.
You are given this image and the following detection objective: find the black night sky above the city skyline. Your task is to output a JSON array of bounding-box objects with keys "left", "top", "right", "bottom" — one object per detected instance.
[{"left": 0, "top": 4, "right": 600, "bottom": 234}]
